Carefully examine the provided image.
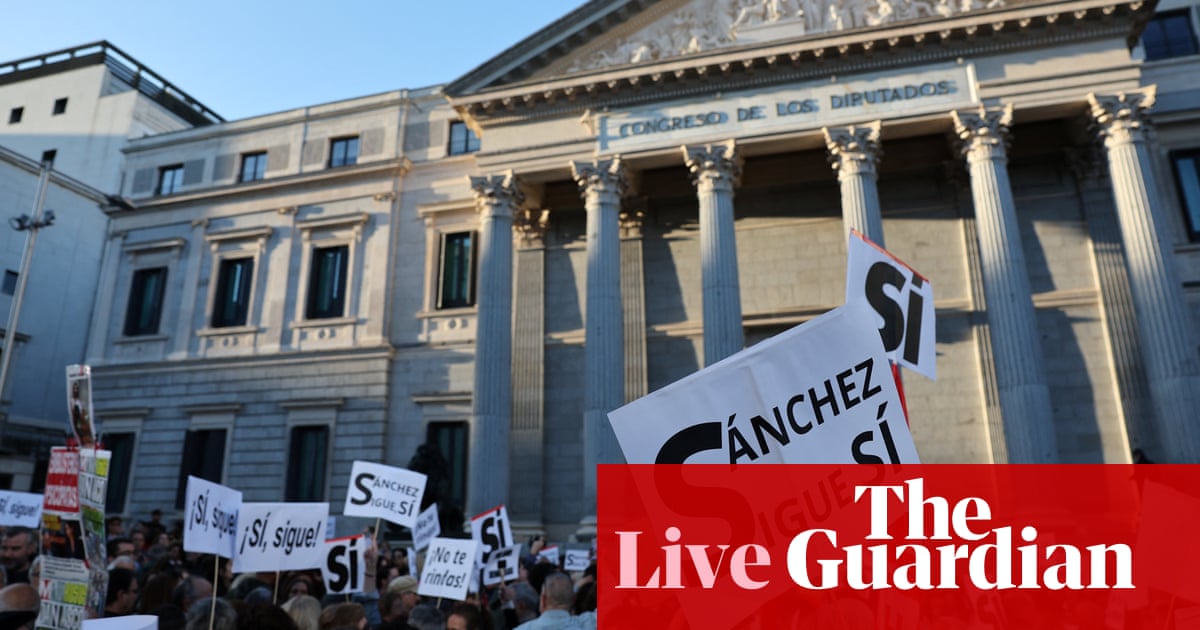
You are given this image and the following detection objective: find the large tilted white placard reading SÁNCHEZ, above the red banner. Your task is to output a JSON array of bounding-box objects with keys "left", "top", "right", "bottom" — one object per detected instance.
[{"left": 608, "top": 304, "right": 918, "bottom": 463}]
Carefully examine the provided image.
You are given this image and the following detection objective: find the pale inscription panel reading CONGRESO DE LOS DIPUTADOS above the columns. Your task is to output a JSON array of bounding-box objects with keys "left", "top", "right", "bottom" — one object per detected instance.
[{"left": 589, "top": 64, "right": 978, "bottom": 154}]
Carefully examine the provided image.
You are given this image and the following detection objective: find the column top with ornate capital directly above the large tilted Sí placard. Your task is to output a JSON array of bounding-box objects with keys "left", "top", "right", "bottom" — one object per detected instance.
[{"left": 821, "top": 120, "right": 883, "bottom": 247}]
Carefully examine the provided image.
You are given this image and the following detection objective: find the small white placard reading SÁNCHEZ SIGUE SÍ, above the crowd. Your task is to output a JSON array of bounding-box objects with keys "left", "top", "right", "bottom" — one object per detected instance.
[{"left": 342, "top": 460, "right": 425, "bottom": 528}]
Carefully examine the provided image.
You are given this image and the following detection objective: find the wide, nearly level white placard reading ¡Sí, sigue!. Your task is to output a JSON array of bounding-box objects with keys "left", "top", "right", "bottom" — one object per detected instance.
[{"left": 233, "top": 503, "right": 329, "bottom": 574}]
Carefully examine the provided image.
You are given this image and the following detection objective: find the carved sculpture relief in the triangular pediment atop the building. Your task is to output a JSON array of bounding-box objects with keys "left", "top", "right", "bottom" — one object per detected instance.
[{"left": 568, "top": 0, "right": 1006, "bottom": 72}]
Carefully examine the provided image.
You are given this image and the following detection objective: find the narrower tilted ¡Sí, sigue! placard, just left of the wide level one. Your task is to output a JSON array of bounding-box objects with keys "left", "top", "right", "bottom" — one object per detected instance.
[{"left": 184, "top": 475, "right": 241, "bottom": 558}]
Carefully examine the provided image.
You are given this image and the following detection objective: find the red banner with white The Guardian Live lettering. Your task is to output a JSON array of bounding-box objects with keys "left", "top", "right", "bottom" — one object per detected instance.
[{"left": 598, "top": 464, "right": 1200, "bottom": 630}]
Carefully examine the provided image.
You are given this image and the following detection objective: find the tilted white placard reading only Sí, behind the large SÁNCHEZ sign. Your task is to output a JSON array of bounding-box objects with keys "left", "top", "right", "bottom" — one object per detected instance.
[{"left": 846, "top": 230, "right": 937, "bottom": 380}]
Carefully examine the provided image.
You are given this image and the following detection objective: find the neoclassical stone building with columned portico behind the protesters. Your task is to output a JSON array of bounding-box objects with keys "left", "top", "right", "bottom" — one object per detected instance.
[{"left": 89, "top": 0, "right": 1200, "bottom": 538}]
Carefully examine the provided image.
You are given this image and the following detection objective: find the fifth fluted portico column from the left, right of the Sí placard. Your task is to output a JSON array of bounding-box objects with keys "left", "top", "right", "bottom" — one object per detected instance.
[{"left": 952, "top": 104, "right": 1058, "bottom": 463}]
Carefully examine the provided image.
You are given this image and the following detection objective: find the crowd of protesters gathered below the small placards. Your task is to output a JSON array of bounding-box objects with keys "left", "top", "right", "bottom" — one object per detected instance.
[{"left": 0, "top": 510, "right": 596, "bottom": 630}]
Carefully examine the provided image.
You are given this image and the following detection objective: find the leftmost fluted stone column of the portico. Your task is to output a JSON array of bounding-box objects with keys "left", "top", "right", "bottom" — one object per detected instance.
[{"left": 467, "top": 170, "right": 523, "bottom": 514}]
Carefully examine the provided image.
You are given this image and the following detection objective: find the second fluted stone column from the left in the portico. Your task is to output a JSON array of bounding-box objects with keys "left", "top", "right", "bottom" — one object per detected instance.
[{"left": 571, "top": 157, "right": 628, "bottom": 506}]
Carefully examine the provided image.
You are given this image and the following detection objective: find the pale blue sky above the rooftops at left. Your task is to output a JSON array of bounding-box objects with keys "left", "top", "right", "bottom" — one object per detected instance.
[{"left": 0, "top": 0, "right": 583, "bottom": 120}]
